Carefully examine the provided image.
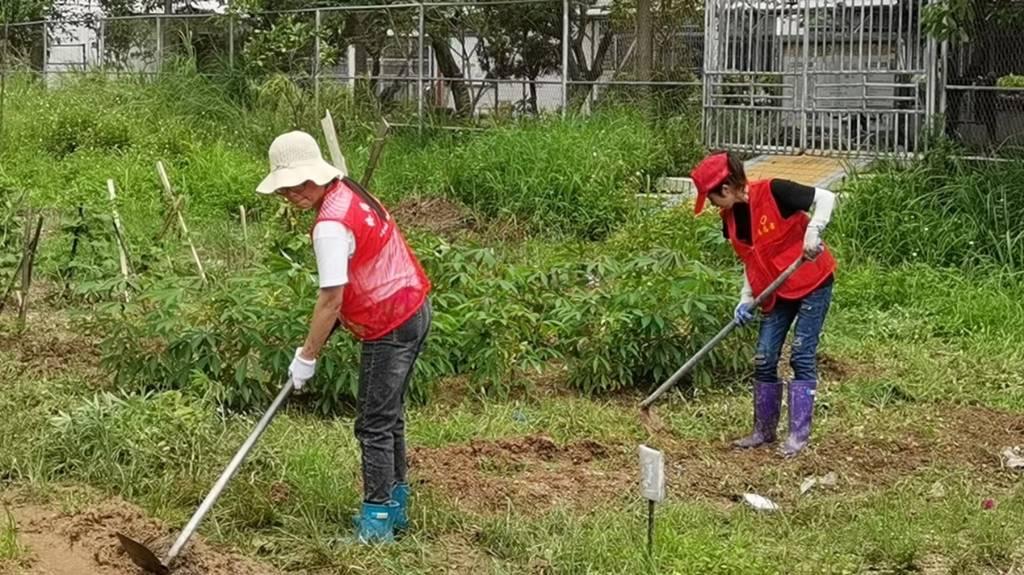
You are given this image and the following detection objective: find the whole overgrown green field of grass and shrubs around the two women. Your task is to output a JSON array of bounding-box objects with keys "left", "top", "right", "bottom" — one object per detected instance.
[{"left": 0, "top": 64, "right": 1024, "bottom": 573}]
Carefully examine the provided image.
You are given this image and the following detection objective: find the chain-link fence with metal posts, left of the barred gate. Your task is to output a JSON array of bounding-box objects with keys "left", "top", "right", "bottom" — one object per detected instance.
[{"left": 0, "top": 0, "right": 703, "bottom": 126}]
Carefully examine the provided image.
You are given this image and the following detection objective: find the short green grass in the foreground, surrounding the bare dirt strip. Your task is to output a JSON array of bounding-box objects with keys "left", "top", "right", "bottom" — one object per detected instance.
[{"left": 0, "top": 269, "right": 1024, "bottom": 574}]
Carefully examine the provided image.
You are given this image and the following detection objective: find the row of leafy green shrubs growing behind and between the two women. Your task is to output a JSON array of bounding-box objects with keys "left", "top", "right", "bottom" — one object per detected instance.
[{"left": 103, "top": 212, "right": 746, "bottom": 411}]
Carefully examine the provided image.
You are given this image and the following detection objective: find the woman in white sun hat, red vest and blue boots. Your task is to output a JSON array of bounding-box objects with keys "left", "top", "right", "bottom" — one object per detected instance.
[{"left": 256, "top": 131, "right": 431, "bottom": 542}]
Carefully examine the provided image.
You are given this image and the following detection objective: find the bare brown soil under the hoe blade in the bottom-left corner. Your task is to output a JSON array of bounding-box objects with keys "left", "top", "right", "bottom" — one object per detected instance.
[{"left": 0, "top": 493, "right": 280, "bottom": 575}]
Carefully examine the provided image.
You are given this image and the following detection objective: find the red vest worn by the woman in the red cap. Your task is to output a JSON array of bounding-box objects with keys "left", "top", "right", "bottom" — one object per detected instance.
[{"left": 721, "top": 180, "right": 836, "bottom": 312}]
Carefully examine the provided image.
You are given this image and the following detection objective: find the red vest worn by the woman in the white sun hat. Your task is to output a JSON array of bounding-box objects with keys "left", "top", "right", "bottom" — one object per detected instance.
[{"left": 313, "top": 179, "right": 430, "bottom": 341}]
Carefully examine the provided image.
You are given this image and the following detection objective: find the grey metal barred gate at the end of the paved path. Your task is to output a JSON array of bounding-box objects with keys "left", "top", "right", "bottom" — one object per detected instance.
[{"left": 703, "top": 0, "right": 935, "bottom": 156}]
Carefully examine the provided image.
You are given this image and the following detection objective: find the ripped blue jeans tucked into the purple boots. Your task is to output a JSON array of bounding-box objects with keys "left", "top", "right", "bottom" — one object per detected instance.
[{"left": 754, "top": 278, "right": 833, "bottom": 384}]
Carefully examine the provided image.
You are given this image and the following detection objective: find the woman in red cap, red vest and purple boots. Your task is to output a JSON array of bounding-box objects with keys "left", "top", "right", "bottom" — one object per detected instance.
[{"left": 690, "top": 152, "right": 836, "bottom": 457}]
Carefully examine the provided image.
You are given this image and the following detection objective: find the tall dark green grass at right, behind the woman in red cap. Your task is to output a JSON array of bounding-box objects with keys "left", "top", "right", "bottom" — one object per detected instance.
[{"left": 834, "top": 148, "right": 1024, "bottom": 271}]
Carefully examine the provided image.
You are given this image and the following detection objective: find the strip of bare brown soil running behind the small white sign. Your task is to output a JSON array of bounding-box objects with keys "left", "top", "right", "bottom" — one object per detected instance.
[{"left": 412, "top": 406, "right": 1024, "bottom": 515}]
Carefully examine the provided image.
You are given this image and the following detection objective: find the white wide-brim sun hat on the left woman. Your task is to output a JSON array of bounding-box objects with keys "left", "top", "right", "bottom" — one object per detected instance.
[{"left": 256, "top": 130, "right": 346, "bottom": 193}]
